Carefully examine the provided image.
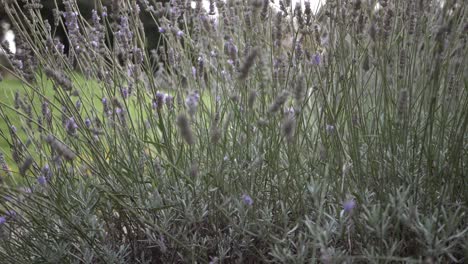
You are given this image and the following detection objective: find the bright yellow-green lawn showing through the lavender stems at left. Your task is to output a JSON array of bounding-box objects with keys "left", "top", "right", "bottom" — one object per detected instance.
[{"left": 0, "top": 72, "right": 181, "bottom": 177}]
